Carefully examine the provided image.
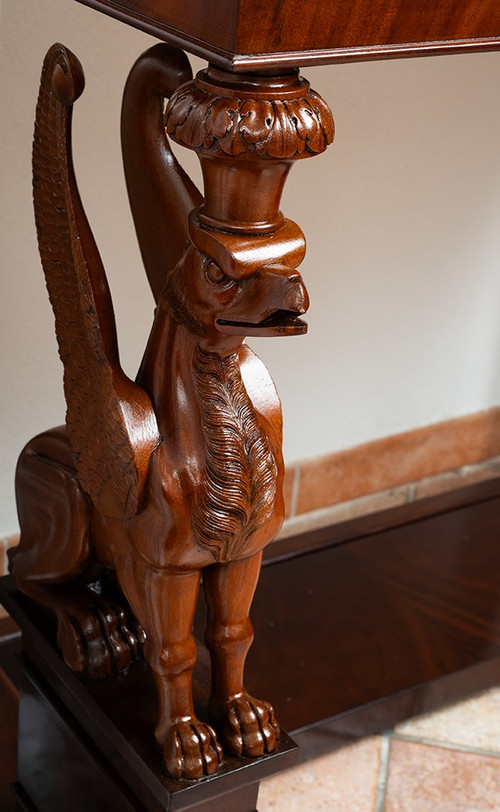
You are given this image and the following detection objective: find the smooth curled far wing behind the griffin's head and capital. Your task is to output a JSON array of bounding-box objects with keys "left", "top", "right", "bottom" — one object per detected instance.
[{"left": 121, "top": 43, "right": 203, "bottom": 301}]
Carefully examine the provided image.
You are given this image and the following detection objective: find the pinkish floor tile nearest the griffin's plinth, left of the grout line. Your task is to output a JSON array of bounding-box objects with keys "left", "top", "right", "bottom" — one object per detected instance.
[{"left": 258, "top": 737, "right": 380, "bottom": 812}]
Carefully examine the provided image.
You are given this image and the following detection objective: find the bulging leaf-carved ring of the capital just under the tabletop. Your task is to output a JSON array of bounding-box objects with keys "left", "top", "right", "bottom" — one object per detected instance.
[{"left": 165, "top": 69, "right": 334, "bottom": 160}]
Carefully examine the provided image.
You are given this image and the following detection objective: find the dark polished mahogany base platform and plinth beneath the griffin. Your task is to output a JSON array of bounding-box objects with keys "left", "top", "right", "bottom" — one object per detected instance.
[{"left": 1, "top": 479, "right": 500, "bottom": 812}]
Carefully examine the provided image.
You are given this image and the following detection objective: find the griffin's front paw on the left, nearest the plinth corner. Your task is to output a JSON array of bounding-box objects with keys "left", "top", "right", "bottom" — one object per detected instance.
[{"left": 163, "top": 717, "right": 222, "bottom": 779}]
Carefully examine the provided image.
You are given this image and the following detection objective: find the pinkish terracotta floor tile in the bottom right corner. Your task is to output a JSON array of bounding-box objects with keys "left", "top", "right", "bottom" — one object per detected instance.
[{"left": 384, "top": 739, "right": 500, "bottom": 812}]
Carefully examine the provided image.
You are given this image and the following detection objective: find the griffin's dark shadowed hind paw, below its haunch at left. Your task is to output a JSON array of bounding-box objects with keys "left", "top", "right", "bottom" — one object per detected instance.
[{"left": 57, "top": 591, "right": 144, "bottom": 678}]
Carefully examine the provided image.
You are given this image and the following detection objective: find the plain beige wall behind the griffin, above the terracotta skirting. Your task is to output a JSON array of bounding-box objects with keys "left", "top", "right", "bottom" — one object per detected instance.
[{"left": 0, "top": 0, "right": 500, "bottom": 537}]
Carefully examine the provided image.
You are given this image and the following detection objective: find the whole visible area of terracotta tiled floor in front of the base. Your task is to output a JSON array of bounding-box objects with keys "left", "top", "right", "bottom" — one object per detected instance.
[{"left": 259, "top": 688, "right": 500, "bottom": 812}]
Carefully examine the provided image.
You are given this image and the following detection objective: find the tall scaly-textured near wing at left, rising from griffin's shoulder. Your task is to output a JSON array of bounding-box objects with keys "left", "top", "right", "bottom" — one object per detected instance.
[{"left": 33, "top": 44, "right": 160, "bottom": 518}]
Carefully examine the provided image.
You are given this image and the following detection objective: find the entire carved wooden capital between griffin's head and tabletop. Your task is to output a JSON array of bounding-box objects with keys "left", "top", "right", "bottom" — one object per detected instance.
[{"left": 165, "top": 66, "right": 334, "bottom": 234}]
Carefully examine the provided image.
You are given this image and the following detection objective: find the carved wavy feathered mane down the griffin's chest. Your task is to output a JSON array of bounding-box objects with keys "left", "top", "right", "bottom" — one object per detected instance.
[{"left": 192, "top": 346, "right": 277, "bottom": 563}]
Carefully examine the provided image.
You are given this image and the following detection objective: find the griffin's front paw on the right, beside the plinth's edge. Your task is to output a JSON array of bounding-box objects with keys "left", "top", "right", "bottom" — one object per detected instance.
[{"left": 210, "top": 693, "right": 280, "bottom": 757}]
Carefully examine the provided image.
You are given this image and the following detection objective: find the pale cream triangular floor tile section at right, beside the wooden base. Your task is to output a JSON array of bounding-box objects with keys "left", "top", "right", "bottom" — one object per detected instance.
[{"left": 396, "top": 688, "right": 500, "bottom": 752}]
